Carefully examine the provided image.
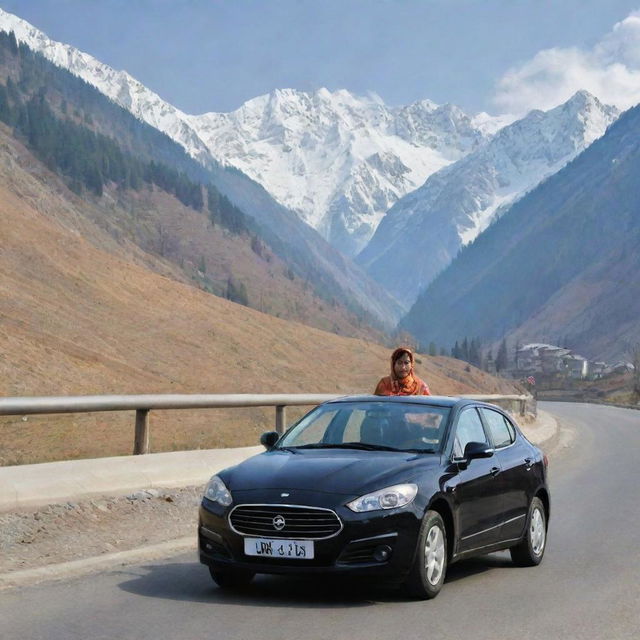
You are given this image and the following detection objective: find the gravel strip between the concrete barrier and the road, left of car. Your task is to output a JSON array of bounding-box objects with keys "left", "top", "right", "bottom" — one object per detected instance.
[{"left": 0, "top": 486, "right": 204, "bottom": 574}]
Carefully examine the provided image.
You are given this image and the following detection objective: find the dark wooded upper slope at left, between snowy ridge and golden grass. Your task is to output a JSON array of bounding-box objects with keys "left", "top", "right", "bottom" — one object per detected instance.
[{"left": 0, "top": 32, "right": 399, "bottom": 335}]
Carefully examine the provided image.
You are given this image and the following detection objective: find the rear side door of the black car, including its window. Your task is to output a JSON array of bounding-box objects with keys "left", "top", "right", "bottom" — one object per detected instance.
[{"left": 480, "top": 407, "right": 535, "bottom": 540}]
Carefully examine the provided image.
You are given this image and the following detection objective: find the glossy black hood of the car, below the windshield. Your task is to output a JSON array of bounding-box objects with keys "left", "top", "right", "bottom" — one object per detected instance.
[{"left": 221, "top": 449, "right": 440, "bottom": 495}]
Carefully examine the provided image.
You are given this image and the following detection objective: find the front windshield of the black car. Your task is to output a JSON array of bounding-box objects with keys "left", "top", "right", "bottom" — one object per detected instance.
[{"left": 277, "top": 401, "right": 449, "bottom": 453}]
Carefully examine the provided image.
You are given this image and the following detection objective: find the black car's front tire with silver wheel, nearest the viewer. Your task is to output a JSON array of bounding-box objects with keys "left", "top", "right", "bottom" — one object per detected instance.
[{"left": 404, "top": 511, "right": 447, "bottom": 600}]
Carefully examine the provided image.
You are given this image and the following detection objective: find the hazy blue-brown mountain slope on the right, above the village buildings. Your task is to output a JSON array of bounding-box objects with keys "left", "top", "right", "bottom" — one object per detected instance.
[{"left": 401, "top": 100, "right": 640, "bottom": 361}]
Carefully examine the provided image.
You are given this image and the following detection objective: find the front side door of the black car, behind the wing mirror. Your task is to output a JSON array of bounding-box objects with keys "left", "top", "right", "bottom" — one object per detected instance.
[{"left": 449, "top": 407, "right": 504, "bottom": 553}]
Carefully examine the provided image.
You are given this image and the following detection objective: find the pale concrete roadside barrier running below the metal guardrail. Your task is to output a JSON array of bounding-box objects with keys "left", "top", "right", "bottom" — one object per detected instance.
[{"left": 0, "top": 411, "right": 559, "bottom": 512}]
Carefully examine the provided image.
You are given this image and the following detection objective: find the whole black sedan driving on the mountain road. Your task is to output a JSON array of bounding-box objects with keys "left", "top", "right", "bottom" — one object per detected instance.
[{"left": 198, "top": 396, "right": 550, "bottom": 599}]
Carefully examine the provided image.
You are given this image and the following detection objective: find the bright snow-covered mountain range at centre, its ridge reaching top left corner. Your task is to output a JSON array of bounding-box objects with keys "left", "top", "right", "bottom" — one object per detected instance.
[{"left": 0, "top": 10, "right": 504, "bottom": 255}]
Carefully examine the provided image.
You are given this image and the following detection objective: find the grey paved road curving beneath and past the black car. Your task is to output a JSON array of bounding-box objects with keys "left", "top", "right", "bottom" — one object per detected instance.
[{"left": 0, "top": 403, "right": 640, "bottom": 640}]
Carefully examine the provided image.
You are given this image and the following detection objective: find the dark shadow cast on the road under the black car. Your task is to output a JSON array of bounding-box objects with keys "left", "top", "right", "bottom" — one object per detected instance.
[{"left": 119, "top": 554, "right": 514, "bottom": 609}]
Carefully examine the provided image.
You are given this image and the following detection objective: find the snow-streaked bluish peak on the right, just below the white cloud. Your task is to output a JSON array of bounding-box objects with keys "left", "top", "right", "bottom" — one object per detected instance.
[{"left": 357, "top": 91, "right": 619, "bottom": 305}]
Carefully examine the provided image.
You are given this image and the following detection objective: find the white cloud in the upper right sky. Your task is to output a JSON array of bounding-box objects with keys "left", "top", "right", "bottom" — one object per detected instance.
[{"left": 493, "top": 11, "right": 640, "bottom": 114}]
